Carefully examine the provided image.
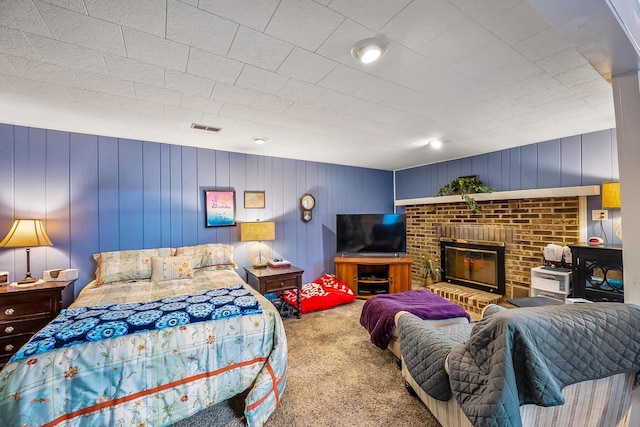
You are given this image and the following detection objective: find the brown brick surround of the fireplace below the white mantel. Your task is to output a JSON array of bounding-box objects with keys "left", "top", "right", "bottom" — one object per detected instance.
[{"left": 405, "top": 196, "right": 580, "bottom": 298}]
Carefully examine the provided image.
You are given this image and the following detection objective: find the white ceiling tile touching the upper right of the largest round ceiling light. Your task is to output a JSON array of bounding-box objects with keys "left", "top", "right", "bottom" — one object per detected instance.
[{"left": 381, "top": 0, "right": 465, "bottom": 50}]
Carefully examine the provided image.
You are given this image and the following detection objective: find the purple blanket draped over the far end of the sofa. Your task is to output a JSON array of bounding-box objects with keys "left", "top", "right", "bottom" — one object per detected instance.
[{"left": 360, "top": 289, "right": 471, "bottom": 350}]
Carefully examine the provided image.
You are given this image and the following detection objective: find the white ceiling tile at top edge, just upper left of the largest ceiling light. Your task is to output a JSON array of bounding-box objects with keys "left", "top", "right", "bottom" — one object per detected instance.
[{"left": 265, "top": 0, "right": 344, "bottom": 52}]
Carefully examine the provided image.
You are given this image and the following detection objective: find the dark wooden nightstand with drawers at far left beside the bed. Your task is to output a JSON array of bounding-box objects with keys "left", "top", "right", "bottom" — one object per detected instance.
[{"left": 0, "top": 281, "right": 75, "bottom": 368}]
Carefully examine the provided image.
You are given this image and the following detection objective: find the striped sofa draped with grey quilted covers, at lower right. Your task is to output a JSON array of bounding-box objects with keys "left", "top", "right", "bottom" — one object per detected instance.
[{"left": 395, "top": 303, "right": 640, "bottom": 427}]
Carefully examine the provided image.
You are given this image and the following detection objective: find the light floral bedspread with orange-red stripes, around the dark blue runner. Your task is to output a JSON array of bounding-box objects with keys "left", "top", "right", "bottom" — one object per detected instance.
[{"left": 0, "top": 270, "right": 287, "bottom": 427}]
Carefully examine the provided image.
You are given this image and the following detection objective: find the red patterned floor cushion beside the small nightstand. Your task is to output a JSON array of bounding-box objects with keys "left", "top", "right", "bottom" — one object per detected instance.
[{"left": 283, "top": 274, "right": 356, "bottom": 314}]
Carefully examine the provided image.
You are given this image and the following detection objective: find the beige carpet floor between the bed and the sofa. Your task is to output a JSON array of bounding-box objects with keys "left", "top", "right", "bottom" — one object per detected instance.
[{"left": 174, "top": 300, "right": 440, "bottom": 427}]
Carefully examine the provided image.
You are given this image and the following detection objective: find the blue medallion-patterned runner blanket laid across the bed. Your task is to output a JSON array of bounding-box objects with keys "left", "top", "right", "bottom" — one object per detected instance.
[{"left": 11, "top": 284, "right": 262, "bottom": 361}]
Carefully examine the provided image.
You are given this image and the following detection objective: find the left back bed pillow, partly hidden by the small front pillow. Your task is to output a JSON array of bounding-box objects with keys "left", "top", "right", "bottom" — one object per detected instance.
[{"left": 93, "top": 248, "right": 173, "bottom": 285}]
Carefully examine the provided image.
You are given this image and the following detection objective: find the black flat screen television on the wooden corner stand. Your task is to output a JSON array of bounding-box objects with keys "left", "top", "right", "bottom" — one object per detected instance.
[{"left": 336, "top": 214, "right": 407, "bottom": 255}]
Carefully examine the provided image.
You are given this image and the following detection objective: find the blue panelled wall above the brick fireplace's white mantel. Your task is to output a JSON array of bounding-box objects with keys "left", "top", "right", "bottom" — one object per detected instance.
[{"left": 395, "top": 129, "right": 622, "bottom": 244}]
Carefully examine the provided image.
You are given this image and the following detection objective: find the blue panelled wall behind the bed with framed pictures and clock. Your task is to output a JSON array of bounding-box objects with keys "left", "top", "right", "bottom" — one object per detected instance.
[{"left": 0, "top": 124, "right": 393, "bottom": 293}]
